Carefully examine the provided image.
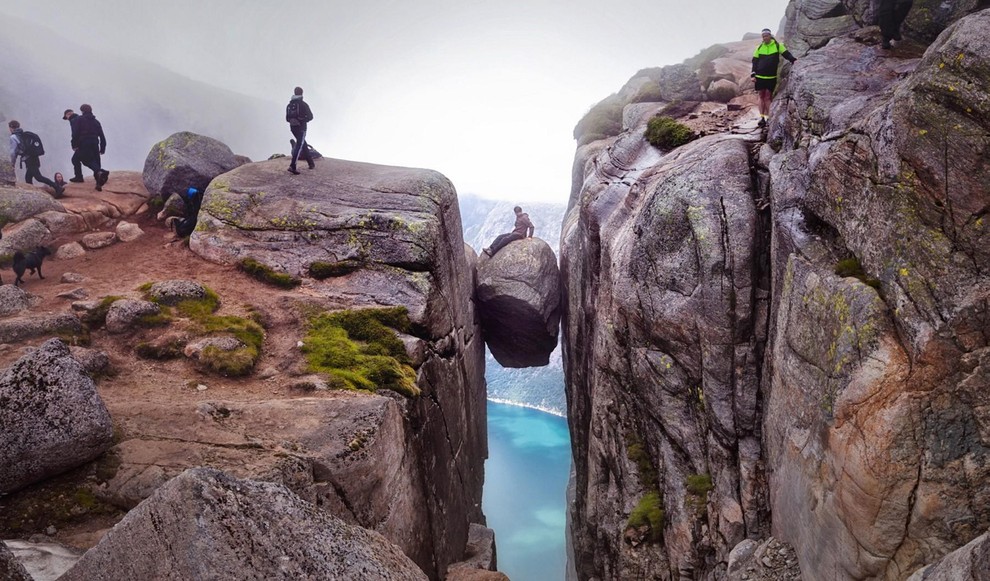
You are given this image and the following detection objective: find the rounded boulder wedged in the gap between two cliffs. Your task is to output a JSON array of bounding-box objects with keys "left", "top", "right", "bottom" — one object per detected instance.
[{"left": 475, "top": 238, "right": 560, "bottom": 367}]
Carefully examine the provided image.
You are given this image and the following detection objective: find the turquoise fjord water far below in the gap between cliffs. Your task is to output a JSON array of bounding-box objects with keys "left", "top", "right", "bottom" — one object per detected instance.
[{"left": 482, "top": 401, "right": 571, "bottom": 581}]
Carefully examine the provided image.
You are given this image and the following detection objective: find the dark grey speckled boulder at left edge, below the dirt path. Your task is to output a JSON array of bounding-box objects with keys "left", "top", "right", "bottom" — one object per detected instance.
[{"left": 0, "top": 339, "right": 112, "bottom": 493}]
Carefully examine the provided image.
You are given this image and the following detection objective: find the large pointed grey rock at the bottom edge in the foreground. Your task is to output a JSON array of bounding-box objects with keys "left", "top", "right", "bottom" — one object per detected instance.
[{"left": 60, "top": 468, "right": 426, "bottom": 581}]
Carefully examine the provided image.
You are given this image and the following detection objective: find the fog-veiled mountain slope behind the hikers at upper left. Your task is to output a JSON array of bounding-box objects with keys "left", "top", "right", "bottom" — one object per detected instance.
[{"left": 0, "top": 14, "right": 291, "bottom": 180}]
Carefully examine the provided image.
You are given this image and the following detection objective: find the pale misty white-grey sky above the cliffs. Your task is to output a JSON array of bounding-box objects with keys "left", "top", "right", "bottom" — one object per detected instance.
[{"left": 0, "top": 0, "right": 788, "bottom": 202}]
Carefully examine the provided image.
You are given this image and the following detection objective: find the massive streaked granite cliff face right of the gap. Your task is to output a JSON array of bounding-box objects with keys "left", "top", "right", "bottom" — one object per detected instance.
[{"left": 561, "top": 1, "right": 990, "bottom": 579}]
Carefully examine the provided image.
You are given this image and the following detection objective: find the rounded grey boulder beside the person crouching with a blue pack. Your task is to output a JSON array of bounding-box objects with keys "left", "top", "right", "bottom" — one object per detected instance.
[{"left": 144, "top": 131, "right": 243, "bottom": 199}]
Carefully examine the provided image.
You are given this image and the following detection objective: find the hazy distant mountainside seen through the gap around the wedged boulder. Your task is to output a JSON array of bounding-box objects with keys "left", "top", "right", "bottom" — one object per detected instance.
[{"left": 458, "top": 195, "right": 567, "bottom": 416}]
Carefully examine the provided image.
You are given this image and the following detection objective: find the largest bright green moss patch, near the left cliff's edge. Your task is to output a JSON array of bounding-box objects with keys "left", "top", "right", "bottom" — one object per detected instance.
[{"left": 303, "top": 307, "right": 419, "bottom": 396}]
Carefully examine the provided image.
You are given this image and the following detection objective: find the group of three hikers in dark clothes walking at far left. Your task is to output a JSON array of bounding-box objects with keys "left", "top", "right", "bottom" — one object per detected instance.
[{"left": 7, "top": 104, "right": 110, "bottom": 198}]
